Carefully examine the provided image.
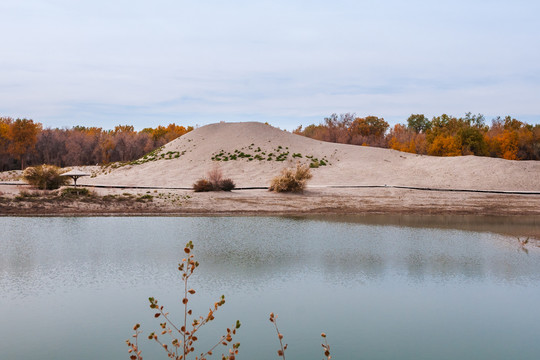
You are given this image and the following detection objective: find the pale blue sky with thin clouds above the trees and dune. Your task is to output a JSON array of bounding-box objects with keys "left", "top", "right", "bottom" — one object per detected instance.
[{"left": 0, "top": 0, "right": 540, "bottom": 130}]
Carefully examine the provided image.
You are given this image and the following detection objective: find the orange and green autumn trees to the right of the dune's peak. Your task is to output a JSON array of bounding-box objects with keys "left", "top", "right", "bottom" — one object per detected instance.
[{"left": 294, "top": 113, "right": 540, "bottom": 160}]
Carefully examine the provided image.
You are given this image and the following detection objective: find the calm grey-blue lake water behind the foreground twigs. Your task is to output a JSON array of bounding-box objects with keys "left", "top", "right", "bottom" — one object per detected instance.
[{"left": 0, "top": 216, "right": 540, "bottom": 359}]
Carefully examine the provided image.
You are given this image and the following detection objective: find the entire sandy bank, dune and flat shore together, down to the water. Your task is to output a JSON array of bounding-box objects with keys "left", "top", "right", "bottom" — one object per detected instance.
[{"left": 0, "top": 123, "right": 540, "bottom": 215}]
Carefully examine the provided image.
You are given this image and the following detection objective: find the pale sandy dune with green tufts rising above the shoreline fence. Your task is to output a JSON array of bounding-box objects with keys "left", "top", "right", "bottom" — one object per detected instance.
[{"left": 81, "top": 122, "right": 540, "bottom": 191}]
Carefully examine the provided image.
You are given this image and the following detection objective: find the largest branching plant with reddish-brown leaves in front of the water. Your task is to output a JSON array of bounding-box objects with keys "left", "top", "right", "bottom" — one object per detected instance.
[{"left": 126, "top": 241, "right": 240, "bottom": 360}]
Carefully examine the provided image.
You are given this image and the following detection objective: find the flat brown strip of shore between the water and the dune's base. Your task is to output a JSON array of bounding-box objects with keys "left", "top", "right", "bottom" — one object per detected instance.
[{"left": 0, "top": 186, "right": 540, "bottom": 216}]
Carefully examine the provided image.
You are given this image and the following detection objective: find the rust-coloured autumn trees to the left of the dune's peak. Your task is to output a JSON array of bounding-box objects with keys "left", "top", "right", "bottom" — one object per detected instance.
[{"left": 0, "top": 117, "right": 193, "bottom": 171}]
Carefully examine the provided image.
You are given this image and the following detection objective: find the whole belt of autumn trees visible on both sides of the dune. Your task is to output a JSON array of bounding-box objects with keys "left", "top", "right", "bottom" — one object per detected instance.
[{"left": 0, "top": 113, "right": 540, "bottom": 171}]
